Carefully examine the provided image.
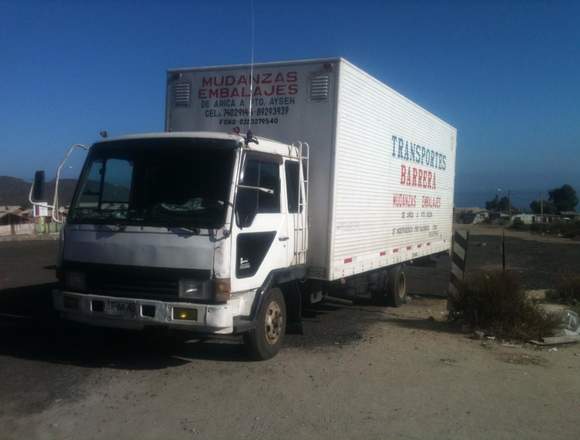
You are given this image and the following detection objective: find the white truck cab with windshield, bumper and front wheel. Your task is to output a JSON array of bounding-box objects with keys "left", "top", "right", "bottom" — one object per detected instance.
[{"left": 53, "top": 132, "right": 308, "bottom": 359}]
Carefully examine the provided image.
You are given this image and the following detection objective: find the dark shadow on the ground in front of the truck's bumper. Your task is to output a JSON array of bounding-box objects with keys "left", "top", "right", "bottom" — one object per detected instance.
[{"left": 0, "top": 283, "right": 251, "bottom": 370}]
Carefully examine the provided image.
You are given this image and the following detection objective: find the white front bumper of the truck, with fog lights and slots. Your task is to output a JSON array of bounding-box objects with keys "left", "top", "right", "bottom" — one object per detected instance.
[{"left": 53, "top": 290, "right": 239, "bottom": 334}]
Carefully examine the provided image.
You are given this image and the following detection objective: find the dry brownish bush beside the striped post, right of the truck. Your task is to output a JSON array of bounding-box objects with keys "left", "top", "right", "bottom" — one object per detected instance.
[{"left": 454, "top": 271, "right": 560, "bottom": 340}]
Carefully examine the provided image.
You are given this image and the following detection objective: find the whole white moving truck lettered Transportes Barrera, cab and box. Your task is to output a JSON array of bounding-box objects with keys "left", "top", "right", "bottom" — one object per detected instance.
[{"left": 42, "top": 58, "right": 456, "bottom": 359}]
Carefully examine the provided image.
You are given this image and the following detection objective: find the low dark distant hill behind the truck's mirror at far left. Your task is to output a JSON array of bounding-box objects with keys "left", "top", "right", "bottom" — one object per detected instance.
[{"left": 0, "top": 176, "right": 77, "bottom": 207}]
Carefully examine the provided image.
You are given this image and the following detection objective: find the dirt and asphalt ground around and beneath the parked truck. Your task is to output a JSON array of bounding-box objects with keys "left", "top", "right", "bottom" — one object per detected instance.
[{"left": 0, "top": 225, "right": 580, "bottom": 439}]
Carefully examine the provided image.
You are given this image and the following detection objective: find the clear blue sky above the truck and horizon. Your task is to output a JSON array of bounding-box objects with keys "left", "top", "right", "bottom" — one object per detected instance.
[{"left": 0, "top": 0, "right": 580, "bottom": 205}]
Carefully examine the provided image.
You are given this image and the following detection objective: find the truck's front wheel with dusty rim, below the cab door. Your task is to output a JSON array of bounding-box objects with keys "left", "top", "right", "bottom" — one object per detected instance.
[{"left": 244, "top": 288, "right": 287, "bottom": 361}]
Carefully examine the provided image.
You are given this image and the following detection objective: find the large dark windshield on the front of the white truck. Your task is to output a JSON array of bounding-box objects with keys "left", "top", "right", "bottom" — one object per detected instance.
[{"left": 68, "top": 138, "right": 236, "bottom": 228}]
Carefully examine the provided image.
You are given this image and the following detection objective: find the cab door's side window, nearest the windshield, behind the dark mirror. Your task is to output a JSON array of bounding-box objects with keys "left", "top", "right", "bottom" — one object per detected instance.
[{"left": 236, "top": 158, "right": 280, "bottom": 227}]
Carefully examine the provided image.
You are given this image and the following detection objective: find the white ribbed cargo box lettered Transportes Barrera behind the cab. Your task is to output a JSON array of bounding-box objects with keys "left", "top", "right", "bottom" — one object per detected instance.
[{"left": 166, "top": 59, "right": 456, "bottom": 280}]
